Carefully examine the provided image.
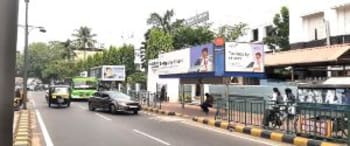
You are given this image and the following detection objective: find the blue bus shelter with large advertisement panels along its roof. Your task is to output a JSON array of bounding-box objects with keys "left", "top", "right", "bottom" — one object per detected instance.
[{"left": 153, "top": 41, "right": 265, "bottom": 107}]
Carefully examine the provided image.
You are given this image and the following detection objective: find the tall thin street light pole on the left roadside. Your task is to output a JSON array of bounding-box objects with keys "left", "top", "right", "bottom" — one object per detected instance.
[{"left": 23, "top": 0, "right": 29, "bottom": 109}]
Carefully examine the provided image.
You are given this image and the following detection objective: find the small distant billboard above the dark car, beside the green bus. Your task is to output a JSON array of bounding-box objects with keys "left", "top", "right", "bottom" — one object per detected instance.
[{"left": 102, "top": 65, "right": 125, "bottom": 81}]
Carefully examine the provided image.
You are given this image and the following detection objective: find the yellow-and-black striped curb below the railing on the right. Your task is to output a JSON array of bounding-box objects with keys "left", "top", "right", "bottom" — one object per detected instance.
[{"left": 192, "top": 117, "right": 338, "bottom": 146}]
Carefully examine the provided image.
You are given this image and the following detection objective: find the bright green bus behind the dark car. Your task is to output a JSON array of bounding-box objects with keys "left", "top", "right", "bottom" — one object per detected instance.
[{"left": 71, "top": 77, "right": 97, "bottom": 99}]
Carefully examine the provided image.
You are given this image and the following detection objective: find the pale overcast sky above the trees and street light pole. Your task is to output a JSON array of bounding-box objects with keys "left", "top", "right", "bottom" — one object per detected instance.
[{"left": 17, "top": 0, "right": 286, "bottom": 50}]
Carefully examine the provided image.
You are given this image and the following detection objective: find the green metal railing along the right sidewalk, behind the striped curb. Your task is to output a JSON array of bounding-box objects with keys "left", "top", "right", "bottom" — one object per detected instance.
[{"left": 215, "top": 96, "right": 350, "bottom": 144}]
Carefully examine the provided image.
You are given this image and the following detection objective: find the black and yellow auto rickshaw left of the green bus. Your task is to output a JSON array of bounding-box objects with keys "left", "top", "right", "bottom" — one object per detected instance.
[{"left": 46, "top": 85, "right": 71, "bottom": 107}]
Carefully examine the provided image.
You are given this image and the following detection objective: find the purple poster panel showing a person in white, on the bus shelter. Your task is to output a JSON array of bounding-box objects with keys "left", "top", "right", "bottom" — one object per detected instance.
[{"left": 189, "top": 43, "right": 214, "bottom": 72}]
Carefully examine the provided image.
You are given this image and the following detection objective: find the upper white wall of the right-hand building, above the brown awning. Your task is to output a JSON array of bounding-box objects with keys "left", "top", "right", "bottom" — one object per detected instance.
[{"left": 289, "top": 0, "right": 350, "bottom": 48}]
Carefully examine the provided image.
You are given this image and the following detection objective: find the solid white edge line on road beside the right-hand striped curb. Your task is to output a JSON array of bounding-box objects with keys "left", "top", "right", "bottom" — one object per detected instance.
[{"left": 182, "top": 121, "right": 278, "bottom": 146}]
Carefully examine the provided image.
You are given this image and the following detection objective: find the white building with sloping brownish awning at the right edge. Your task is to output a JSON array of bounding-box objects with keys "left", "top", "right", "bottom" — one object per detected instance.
[{"left": 265, "top": 0, "right": 350, "bottom": 82}]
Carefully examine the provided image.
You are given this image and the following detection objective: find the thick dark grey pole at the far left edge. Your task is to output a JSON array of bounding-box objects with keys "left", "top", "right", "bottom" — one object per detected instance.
[{"left": 0, "top": 0, "right": 18, "bottom": 146}]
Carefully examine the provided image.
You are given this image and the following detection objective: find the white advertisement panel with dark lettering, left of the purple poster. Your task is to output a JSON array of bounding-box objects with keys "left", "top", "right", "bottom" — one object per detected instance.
[{"left": 158, "top": 48, "right": 190, "bottom": 75}]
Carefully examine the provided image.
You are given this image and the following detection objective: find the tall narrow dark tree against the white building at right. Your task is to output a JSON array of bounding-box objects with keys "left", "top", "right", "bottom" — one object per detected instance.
[{"left": 264, "top": 7, "right": 290, "bottom": 50}]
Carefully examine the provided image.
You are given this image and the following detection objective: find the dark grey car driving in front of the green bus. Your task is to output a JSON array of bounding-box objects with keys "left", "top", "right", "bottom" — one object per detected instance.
[{"left": 88, "top": 91, "right": 141, "bottom": 115}]
